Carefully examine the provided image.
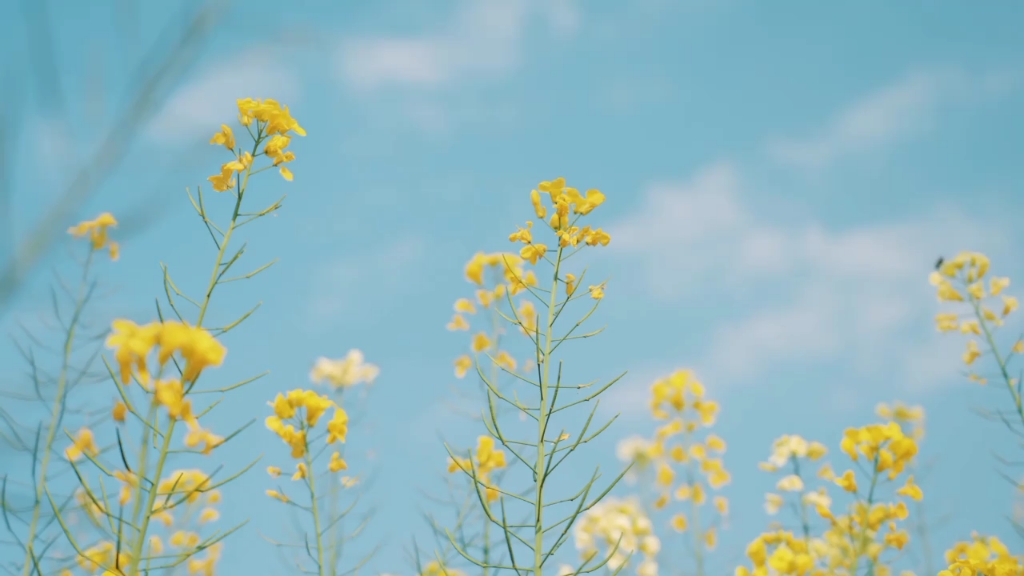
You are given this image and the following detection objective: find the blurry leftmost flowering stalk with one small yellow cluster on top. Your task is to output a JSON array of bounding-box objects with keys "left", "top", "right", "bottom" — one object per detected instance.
[{"left": 0, "top": 212, "right": 120, "bottom": 576}]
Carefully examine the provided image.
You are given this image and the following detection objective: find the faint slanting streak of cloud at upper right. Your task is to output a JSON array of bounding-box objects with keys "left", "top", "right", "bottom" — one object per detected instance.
[{"left": 768, "top": 70, "right": 1018, "bottom": 169}]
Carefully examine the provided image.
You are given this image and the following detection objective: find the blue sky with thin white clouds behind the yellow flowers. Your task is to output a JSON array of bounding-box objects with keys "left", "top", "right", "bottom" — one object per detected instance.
[{"left": 0, "top": 0, "right": 1024, "bottom": 574}]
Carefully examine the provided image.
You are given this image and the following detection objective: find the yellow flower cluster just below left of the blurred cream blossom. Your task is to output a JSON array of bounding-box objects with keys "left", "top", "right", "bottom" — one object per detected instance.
[{"left": 266, "top": 388, "right": 348, "bottom": 485}]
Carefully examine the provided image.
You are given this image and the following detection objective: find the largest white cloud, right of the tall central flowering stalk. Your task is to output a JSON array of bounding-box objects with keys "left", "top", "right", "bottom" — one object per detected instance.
[{"left": 609, "top": 164, "right": 1008, "bottom": 386}]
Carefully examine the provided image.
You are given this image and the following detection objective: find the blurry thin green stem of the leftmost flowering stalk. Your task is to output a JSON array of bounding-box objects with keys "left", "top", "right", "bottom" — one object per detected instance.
[{"left": 22, "top": 246, "right": 95, "bottom": 576}]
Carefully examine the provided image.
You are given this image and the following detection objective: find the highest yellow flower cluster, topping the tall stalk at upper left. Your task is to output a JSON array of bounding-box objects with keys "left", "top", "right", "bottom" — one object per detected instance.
[{"left": 207, "top": 98, "right": 306, "bottom": 192}]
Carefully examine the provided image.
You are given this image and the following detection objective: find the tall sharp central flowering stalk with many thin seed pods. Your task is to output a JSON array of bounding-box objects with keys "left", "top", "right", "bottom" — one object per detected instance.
[{"left": 446, "top": 178, "right": 625, "bottom": 576}]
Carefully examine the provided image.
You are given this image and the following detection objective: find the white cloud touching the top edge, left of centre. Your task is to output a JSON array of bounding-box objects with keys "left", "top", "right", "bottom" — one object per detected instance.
[{"left": 337, "top": 0, "right": 579, "bottom": 90}]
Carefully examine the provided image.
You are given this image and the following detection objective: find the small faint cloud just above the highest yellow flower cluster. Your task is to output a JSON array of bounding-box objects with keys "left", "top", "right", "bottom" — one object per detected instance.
[{"left": 146, "top": 47, "right": 301, "bottom": 140}]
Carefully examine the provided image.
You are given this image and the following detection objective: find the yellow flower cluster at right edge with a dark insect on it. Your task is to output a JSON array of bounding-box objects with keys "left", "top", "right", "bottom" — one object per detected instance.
[{"left": 929, "top": 252, "right": 1024, "bottom": 368}]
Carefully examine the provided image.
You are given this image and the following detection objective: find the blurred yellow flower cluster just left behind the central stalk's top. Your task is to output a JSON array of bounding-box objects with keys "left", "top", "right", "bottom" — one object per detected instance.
[{"left": 446, "top": 252, "right": 538, "bottom": 378}]
